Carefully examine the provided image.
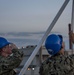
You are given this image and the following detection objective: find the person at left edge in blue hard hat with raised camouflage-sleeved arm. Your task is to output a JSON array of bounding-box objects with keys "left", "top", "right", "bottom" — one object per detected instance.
[{"left": 0, "top": 37, "right": 23, "bottom": 75}]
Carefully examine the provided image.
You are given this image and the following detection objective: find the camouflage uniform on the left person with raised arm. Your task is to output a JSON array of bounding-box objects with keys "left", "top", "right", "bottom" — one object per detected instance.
[{"left": 0, "top": 49, "right": 23, "bottom": 75}]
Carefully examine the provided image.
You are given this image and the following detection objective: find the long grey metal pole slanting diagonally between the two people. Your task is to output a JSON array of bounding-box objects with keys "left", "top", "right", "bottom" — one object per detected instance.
[{"left": 19, "top": 0, "right": 70, "bottom": 75}]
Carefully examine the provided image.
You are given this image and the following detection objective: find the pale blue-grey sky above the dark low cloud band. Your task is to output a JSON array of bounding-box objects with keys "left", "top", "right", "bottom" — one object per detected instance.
[{"left": 0, "top": 0, "right": 72, "bottom": 33}]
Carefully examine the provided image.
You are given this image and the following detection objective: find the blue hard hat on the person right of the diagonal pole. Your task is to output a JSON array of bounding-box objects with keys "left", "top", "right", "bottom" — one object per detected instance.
[{"left": 45, "top": 34, "right": 62, "bottom": 55}]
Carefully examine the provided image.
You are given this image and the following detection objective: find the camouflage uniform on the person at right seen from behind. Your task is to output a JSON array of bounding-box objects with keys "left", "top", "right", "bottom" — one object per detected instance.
[{"left": 39, "top": 54, "right": 74, "bottom": 75}]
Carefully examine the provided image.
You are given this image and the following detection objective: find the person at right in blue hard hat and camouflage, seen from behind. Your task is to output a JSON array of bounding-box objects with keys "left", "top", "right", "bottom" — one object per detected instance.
[{"left": 39, "top": 34, "right": 74, "bottom": 75}]
